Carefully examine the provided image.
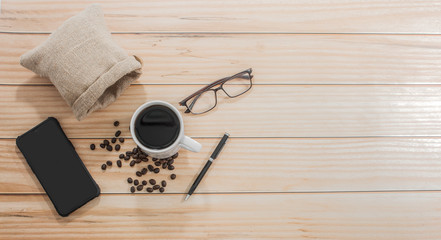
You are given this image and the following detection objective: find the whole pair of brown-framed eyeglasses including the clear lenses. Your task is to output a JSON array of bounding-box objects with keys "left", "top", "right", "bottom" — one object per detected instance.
[{"left": 179, "top": 68, "right": 253, "bottom": 114}]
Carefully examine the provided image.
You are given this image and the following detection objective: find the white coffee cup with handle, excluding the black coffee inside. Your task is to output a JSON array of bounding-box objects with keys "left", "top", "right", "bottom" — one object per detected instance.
[{"left": 130, "top": 100, "right": 202, "bottom": 158}]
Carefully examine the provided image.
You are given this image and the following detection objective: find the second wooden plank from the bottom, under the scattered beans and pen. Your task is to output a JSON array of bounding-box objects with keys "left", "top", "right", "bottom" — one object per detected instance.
[{"left": 0, "top": 138, "right": 441, "bottom": 193}]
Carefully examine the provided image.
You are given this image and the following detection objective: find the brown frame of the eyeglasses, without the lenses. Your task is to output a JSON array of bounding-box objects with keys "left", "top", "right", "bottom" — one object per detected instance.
[{"left": 179, "top": 68, "right": 253, "bottom": 114}]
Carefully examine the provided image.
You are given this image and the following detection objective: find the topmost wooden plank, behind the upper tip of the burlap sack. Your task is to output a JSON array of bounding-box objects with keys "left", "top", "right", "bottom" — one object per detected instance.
[{"left": 0, "top": 0, "right": 441, "bottom": 34}]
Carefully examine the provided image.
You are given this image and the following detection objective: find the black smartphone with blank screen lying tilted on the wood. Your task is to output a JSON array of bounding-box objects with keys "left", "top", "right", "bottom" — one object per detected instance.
[{"left": 17, "top": 117, "right": 100, "bottom": 217}]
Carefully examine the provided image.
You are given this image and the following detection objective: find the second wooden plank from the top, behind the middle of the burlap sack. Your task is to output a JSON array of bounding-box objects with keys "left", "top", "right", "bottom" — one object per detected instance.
[{"left": 0, "top": 34, "right": 441, "bottom": 84}]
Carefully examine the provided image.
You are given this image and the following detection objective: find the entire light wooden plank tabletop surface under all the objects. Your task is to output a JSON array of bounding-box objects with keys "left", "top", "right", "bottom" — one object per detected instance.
[{"left": 0, "top": 0, "right": 441, "bottom": 239}]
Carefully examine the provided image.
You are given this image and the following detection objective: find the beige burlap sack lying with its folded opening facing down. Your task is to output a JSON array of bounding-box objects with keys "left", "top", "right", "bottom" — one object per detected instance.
[{"left": 20, "top": 5, "right": 142, "bottom": 120}]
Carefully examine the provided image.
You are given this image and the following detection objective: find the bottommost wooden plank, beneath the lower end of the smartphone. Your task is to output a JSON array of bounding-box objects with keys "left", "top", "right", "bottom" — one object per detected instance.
[{"left": 0, "top": 192, "right": 441, "bottom": 239}]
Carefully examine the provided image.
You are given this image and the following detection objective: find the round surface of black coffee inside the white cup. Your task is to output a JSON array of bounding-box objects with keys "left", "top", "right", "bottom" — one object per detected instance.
[{"left": 135, "top": 105, "right": 180, "bottom": 149}]
